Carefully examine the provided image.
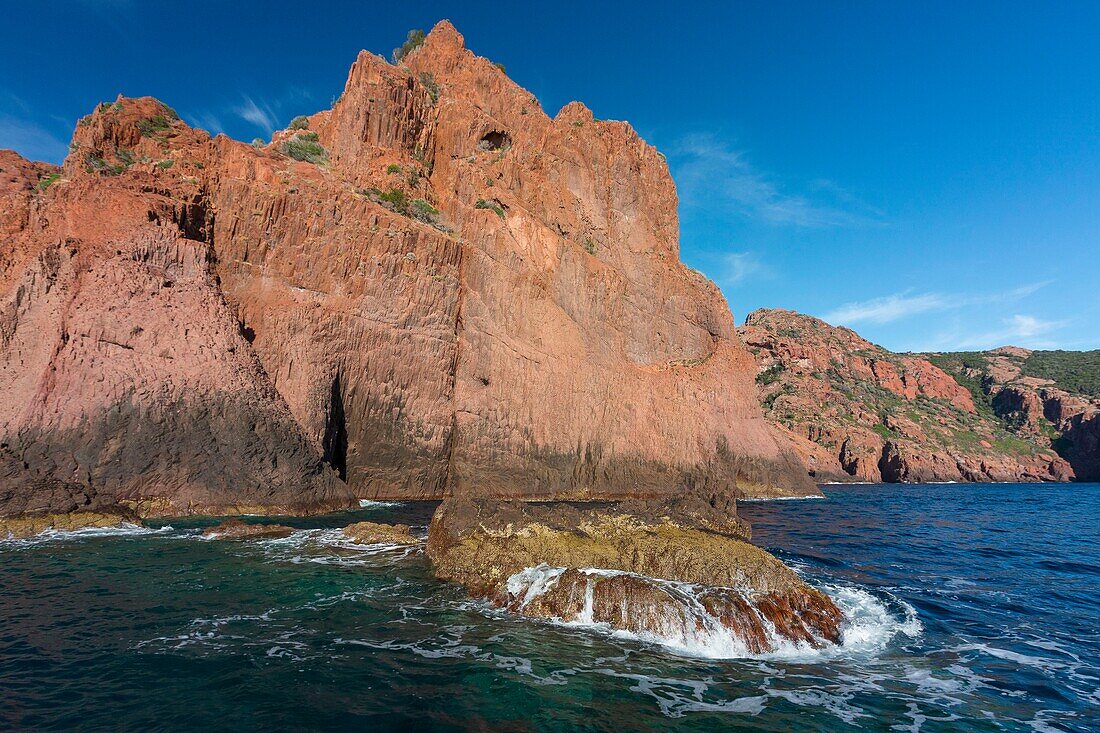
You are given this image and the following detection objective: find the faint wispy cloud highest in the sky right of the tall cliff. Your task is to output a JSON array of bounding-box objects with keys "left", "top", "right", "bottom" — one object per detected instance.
[{"left": 671, "top": 134, "right": 884, "bottom": 228}]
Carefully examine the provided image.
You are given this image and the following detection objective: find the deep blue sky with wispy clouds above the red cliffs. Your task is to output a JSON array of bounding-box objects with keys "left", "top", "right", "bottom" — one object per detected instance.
[{"left": 0, "top": 0, "right": 1100, "bottom": 350}]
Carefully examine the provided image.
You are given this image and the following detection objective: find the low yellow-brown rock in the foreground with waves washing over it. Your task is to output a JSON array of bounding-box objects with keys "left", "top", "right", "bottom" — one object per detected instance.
[{"left": 428, "top": 499, "right": 843, "bottom": 656}]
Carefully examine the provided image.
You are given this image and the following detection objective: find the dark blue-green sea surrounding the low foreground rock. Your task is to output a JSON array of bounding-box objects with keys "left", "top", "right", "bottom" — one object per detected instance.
[{"left": 0, "top": 484, "right": 1100, "bottom": 731}]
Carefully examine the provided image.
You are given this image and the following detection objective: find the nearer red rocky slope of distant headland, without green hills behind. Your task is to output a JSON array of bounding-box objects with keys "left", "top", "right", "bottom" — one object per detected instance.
[{"left": 739, "top": 310, "right": 1074, "bottom": 482}]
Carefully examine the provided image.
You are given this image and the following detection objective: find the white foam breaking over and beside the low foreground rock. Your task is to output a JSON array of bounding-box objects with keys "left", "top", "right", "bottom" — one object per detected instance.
[{"left": 506, "top": 565, "right": 922, "bottom": 661}]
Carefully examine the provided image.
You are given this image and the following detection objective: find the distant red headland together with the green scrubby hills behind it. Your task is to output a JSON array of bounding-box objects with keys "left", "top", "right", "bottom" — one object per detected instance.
[{"left": 739, "top": 309, "right": 1100, "bottom": 482}]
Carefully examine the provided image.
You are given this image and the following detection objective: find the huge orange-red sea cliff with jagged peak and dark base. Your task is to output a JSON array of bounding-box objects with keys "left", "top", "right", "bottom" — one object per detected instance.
[{"left": 0, "top": 22, "right": 816, "bottom": 514}]
